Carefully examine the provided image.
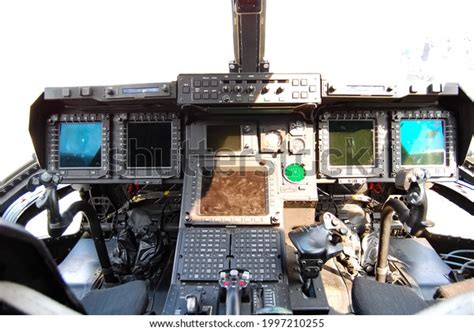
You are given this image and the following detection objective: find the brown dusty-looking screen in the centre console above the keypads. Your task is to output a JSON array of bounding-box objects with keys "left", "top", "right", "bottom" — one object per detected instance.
[{"left": 200, "top": 169, "right": 268, "bottom": 216}]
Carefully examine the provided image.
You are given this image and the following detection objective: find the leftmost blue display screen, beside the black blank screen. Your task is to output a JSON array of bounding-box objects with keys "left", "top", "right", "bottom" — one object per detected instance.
[{"left": 59, "top": 122, "right": 102, "bottom": 168}]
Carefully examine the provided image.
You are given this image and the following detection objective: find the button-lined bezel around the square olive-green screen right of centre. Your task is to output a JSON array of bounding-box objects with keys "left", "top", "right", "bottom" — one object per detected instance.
[{"left": 318, "top": 110, "right": 388, "bottom": 178}]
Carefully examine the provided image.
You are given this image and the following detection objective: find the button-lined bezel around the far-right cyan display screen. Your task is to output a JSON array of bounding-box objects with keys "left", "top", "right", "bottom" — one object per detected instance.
[{"left": 392, "top": 108, "right": 457, "bottom": 179}]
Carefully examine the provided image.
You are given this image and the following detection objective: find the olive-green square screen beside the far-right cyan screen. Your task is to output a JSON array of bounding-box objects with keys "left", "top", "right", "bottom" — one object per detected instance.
[{"left": 329, "top": 120, "right": 375, "bottom": 166}]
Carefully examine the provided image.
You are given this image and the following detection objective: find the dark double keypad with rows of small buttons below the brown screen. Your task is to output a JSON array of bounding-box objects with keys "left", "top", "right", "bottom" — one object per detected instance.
[{"left": 178, "top": 228, "right": 282, "bottom": 281}]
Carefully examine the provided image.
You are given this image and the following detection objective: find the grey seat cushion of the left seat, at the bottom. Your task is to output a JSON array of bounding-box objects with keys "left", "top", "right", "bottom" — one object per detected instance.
[{"left": 81, "top": 280, "right": 148, "bottom": 315}]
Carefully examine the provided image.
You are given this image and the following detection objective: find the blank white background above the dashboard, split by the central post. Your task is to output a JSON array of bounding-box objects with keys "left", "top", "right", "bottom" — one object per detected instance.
[{"left": 0, "top": 0, "right": 474, "bottom": 179}]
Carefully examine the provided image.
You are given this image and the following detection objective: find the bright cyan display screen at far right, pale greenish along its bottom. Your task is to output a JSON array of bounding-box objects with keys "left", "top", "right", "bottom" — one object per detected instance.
[{"left": 400, "top": 120, "right": 446, "bottom": 165}]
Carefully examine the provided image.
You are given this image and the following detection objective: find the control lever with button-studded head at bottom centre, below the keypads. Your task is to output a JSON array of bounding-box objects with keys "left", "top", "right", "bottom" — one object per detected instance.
[{"left": 219, "top": 269, "right": 250, "bottom": 315}]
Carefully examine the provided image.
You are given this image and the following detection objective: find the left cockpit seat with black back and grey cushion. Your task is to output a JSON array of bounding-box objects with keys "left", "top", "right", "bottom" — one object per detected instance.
[{"left": 0, "top": 219, "right": 148, "bottom": 315}]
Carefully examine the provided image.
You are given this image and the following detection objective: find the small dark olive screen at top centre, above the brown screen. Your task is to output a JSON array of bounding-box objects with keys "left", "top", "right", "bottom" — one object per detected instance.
[{"left": 206, "top": 125, "right": 242, "bottom": 152}]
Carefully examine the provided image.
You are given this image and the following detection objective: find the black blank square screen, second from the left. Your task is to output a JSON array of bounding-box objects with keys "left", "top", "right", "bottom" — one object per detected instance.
[{"left": 128, "top": 122, "right": 171, "bottom": 168}]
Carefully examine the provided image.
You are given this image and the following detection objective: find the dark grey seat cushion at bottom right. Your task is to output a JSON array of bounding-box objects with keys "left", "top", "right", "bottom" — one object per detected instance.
[{"left": 352, "top": 277, "right": 429, "bottom": 315}]
